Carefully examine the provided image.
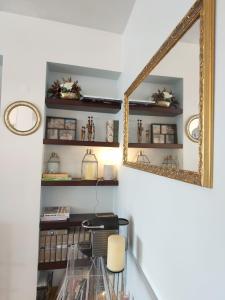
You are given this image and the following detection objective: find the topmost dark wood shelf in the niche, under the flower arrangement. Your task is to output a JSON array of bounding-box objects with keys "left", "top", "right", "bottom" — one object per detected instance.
[{"left": 45, "top": 97, "right": 122, "bottom": 114}]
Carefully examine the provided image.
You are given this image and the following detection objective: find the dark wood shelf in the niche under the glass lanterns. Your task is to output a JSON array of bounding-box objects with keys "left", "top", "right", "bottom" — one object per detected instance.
[{"left": 41, "top": 178, "right": 119, "bottom": 186}]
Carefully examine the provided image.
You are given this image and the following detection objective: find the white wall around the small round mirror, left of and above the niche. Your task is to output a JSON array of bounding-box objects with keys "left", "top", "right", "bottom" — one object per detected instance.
[{"left": 0, "top": 12, "right": 121, "bottom": 300}]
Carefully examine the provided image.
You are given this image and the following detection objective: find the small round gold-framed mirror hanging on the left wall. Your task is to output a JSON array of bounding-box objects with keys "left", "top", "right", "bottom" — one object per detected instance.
[{"left": 4, "top": 101, "right": 41, "bottom": 135}]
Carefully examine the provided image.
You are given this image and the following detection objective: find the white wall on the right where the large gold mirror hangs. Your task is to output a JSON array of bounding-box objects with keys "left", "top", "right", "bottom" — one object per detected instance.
[{"left": 117, "top": 0, "right": 225, "bottom": 300}]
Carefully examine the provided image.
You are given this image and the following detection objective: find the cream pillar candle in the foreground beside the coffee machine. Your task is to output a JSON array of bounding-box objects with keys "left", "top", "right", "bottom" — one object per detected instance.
[{"left": 107, "top": 234, "right": 125, "bottom": 273}]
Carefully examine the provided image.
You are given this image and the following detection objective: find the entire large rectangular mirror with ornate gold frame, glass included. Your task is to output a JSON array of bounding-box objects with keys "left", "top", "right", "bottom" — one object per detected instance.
[{"left": 123, "top": 0, "right": 215, "bottom": 187}]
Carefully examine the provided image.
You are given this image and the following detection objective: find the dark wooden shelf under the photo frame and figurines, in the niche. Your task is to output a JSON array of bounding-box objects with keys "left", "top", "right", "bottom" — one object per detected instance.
[{"left": 43, "top": 139, "right": 120, "bottom": 148}]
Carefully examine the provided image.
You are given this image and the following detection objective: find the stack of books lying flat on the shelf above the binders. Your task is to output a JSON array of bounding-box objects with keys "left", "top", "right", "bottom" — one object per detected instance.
[{"left": 41, "top": 206, "right": 70, "bottom": 221}]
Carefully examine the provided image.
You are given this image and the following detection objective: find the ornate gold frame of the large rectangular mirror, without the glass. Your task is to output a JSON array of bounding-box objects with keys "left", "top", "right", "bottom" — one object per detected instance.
[{"left": 123, "top": 0, "right": 215, "bottom": 188}]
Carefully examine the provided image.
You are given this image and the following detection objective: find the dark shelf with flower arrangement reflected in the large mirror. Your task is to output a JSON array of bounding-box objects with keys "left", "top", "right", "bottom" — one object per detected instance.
[{"left": 129, "top": 102, "right": 183, "bottom": 117}]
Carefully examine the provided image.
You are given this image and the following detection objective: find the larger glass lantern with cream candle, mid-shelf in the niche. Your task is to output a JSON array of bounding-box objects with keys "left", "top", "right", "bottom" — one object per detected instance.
[{"left": 81, "top": 149, "right": 98, "bottom": 180}]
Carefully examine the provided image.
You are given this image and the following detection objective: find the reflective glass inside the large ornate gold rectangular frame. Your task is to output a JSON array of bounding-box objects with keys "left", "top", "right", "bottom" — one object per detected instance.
[{"left": 128, "top": 20, "right": 200, "bottom": 172}]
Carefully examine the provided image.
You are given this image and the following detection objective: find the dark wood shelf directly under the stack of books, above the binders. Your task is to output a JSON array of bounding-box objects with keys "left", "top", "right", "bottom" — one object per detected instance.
[{"left": 40, "top": 214, "right": 95, "bottom": 230}]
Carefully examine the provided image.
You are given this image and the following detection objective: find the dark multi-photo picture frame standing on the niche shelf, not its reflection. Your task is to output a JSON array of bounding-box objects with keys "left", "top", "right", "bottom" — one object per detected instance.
[{"left": 45, "top": 116, "right": 77, "bottom": 140}]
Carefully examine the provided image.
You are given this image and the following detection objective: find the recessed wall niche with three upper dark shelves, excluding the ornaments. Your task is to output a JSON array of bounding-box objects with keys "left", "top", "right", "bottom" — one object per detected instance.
[{"left": 41, "top": 62, "right": 122, "bottom": 213}]
